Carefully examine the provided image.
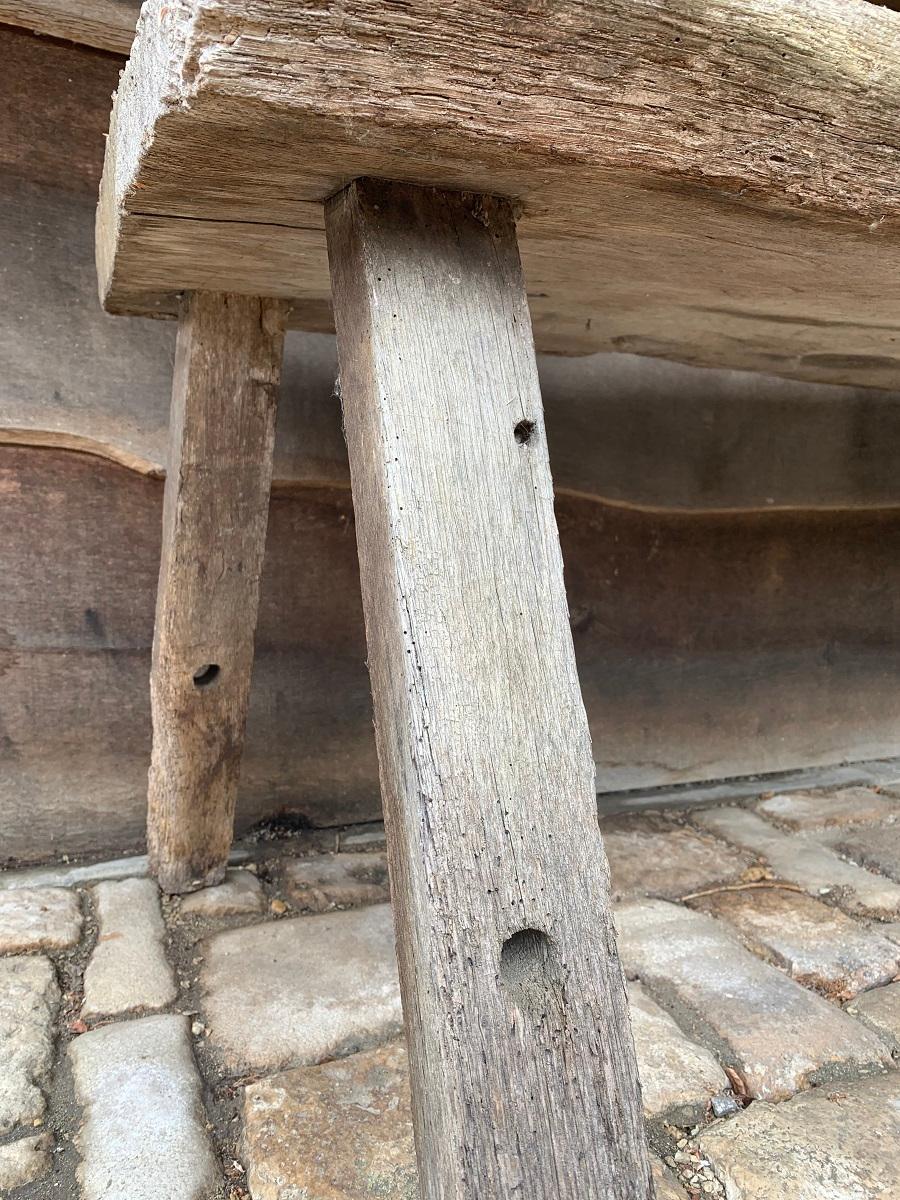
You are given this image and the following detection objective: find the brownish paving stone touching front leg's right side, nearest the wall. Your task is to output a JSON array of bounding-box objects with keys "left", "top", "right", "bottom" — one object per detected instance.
[{"left": 600, "top": 814, "right": 752, "bottom": 900}]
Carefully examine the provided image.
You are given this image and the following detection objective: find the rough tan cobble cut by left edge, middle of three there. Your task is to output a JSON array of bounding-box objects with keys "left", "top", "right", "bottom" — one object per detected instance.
[{"left": 0, "top": 955, "right": 60, "bottom": 1134}]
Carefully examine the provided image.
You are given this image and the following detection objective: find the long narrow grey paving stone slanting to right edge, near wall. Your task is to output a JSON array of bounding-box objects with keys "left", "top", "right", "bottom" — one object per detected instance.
[{"left": 691, "top": 808, "right": 900, "bottom": 920}]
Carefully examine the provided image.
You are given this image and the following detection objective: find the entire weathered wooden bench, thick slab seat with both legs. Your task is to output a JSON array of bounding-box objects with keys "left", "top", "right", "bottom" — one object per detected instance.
[{"left": 88, "top": 0, "right": 900, "bottom": 1200}]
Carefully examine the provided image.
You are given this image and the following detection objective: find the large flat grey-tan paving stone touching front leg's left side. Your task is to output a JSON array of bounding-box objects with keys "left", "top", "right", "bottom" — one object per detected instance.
[{"left": 200, "top": 905, "right": 403, "bottom": 1074}]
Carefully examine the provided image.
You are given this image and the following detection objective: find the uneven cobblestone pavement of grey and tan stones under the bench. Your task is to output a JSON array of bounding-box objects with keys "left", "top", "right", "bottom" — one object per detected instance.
[{"left": 0, "top": 785, "right": 900, "bottom": 1200}]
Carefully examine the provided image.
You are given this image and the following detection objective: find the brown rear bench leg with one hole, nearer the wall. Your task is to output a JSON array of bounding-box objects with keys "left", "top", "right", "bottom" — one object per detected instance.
[{"left": 148, "top": 292, "right": 286, "bottom": 892}]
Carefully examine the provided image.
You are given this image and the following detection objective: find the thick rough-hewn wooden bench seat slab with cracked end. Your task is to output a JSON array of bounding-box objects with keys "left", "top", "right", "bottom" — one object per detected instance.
[{"left": 98, "top": 0, "right": 900, "bottom": 386}]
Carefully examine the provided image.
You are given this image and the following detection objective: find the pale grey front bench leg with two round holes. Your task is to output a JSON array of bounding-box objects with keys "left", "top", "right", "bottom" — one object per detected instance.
[{"left": 326, "top": 180, "right": 653, "bottom": 1200}]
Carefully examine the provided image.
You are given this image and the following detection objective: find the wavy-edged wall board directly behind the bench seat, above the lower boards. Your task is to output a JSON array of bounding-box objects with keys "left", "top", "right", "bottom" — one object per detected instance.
[{"left": 8, "top": 29, "right": 900, "bottom": 501}]
